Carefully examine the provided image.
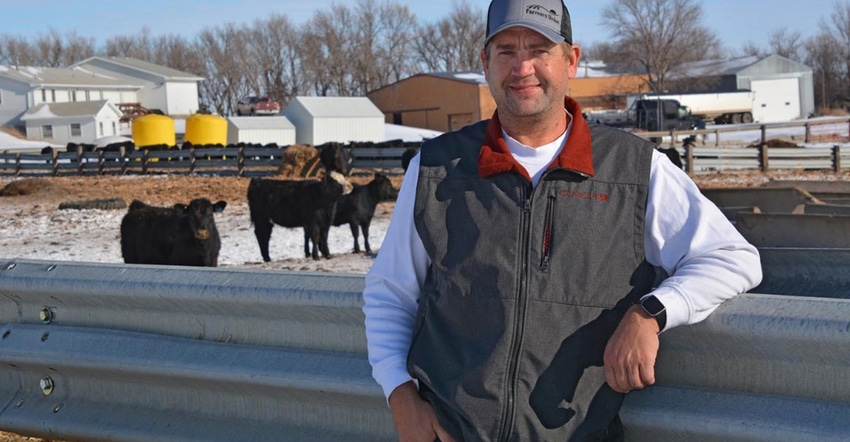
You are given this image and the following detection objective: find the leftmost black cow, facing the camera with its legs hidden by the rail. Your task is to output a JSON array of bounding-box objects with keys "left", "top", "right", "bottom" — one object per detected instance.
[{"left": 121, "top": 198, "right": 227, "bottom": 267}]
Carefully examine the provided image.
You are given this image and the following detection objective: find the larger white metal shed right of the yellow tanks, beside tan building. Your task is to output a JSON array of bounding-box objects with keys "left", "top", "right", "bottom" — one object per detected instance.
[{"left": 283, "top": 97, "right": 385, "bottom": 146}]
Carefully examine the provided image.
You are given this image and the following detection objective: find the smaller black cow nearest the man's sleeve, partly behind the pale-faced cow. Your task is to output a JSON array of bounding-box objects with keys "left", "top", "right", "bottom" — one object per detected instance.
[{"left": 333, "top": 174, "right": 398, "bottom": 254}]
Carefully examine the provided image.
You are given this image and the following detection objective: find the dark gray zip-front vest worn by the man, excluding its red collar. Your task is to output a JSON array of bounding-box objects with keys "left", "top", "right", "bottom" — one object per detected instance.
[{"left": 408, "top": 122, "right": 654, "bottom": 442}]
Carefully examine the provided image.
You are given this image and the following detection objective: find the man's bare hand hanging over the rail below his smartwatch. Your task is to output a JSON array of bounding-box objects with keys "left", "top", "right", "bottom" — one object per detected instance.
[{"left": 603, "top": 305, "right": 660, "bottom": 393}]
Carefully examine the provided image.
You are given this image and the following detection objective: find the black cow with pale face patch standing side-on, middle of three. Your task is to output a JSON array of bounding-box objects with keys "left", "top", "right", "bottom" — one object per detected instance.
[{"left": 248, "top": 172, "right": 351, "bottom": 262}]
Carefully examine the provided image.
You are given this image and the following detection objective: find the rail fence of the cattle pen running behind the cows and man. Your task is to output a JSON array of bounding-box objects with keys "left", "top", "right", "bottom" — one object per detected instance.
[{"left": 0, "top": 117, "right": 850, "bottom": 176}]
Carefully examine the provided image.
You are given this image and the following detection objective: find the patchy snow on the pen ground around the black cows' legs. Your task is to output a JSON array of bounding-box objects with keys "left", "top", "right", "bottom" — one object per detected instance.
[{"left": 0, "top": 203, "right": 391, "bottom": 274}]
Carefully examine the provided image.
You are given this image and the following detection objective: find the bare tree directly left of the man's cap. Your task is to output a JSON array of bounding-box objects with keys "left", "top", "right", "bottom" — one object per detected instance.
[{"left": 415, "top": 0, "right": 487, "bottom": 72}]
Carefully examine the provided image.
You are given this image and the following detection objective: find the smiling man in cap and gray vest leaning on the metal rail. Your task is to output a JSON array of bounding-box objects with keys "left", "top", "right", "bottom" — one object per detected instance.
[{"left": 363, "top": 0, "right": 761, "bottom": 442}]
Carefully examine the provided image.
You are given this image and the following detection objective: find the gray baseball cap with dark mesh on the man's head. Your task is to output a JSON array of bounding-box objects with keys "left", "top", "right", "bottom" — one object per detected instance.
[{"left": 484, "top": 0, "right": 573, "bottom": 45}]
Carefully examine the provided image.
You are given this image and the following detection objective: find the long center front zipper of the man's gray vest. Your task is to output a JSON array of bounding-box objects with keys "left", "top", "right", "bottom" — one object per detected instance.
[{"left": 497, "top": 187, "right": 532, "bottom": 441}]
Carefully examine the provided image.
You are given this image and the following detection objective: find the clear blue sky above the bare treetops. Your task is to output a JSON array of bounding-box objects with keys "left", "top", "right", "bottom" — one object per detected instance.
[{"left": 0, "top": 0, "right": 836, "bottom": 50}]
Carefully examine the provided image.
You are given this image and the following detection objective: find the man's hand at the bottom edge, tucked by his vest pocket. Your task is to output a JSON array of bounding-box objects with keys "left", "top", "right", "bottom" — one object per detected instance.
[{"left": 389, "top": 382, "right": 454, "bottom": 442}]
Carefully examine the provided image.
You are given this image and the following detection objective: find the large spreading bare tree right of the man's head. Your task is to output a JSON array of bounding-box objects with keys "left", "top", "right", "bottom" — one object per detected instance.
[{"left": 602, "top": 0, "right": 719, "bottom": 92}]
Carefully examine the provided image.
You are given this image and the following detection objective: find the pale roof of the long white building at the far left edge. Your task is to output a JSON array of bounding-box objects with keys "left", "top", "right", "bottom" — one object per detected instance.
[{"left": 0, "top": 66, "right": 135, "bottom": 90}]
